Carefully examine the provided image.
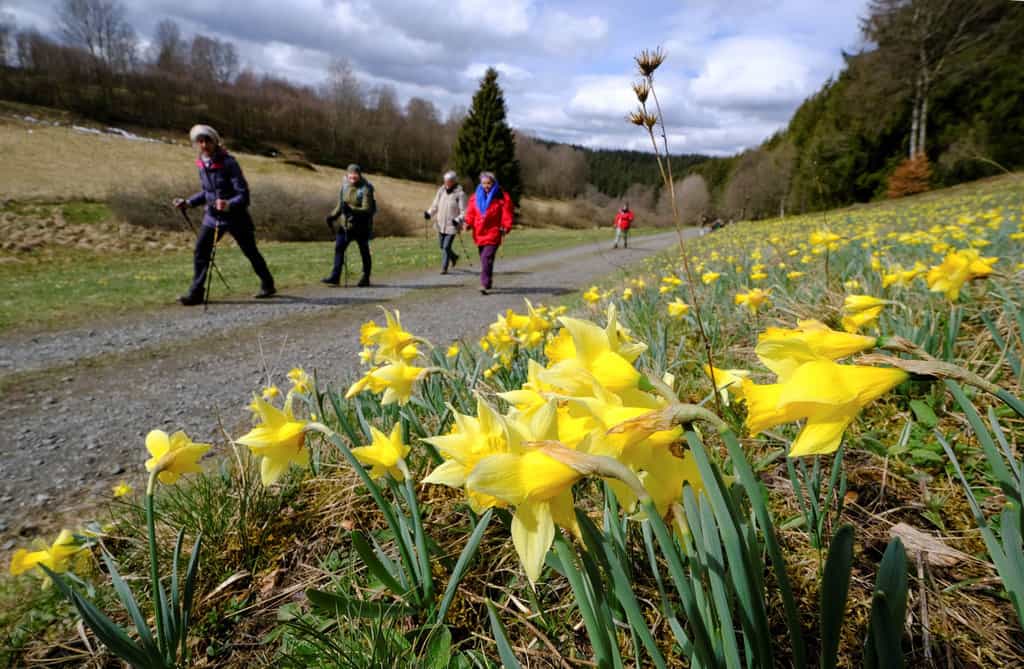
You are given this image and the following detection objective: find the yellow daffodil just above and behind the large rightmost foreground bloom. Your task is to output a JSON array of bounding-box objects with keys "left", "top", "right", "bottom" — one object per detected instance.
[{"left": 754, "top": 321, "right": 878, "bottom": 383}]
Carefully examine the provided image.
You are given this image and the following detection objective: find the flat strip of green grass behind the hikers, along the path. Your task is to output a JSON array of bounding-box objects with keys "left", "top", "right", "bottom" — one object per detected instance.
[{"left": 0, "top": 227, "right": 655, "bottom": 330}]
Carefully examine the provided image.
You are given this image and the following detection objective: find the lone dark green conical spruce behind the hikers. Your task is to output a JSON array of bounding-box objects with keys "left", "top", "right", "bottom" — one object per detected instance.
[{"left": 455, "top": 68, "right": 522, "bottom": 206}]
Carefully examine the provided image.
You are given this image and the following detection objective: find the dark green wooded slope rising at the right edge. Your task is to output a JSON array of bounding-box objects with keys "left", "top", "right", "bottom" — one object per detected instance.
[{"left": 691, "top": 0, "right": 1024, "bottom": 218}]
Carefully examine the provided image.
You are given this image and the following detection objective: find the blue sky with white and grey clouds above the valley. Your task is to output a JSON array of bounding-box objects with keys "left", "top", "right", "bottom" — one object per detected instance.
[{"left": 6, "top": 0, "right": 867, "bottom": 155}]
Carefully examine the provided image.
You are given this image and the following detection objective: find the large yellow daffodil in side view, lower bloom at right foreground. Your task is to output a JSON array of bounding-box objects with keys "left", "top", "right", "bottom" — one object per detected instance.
[{"left": 743, "top": 360, "right": 908, "bottom": 457}]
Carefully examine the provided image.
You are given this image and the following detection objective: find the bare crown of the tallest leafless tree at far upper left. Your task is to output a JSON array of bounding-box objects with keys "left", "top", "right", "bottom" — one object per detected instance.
[{"left": 57, "top": 0, "right": 136, "bottom": 72}]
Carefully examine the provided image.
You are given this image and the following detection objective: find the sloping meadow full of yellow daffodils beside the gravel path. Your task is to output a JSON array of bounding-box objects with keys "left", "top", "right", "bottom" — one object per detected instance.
[{"left": 0, "top": 166, "right": 1024, "bottom": 667}]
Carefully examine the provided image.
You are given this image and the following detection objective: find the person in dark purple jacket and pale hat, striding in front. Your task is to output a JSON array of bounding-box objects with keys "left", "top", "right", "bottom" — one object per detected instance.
[{"left": 174, "top": 125, "right": 278, "bottom": 306}]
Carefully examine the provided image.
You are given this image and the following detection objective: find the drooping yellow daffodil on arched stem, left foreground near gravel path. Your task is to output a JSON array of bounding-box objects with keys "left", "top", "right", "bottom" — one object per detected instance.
[{"left": 234, "top": 398, "right": 309, "bottom": 486}]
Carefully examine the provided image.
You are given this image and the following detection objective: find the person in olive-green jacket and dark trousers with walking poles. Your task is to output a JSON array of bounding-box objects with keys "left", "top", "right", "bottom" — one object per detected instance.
[{"left": 321, "top": 163, "right": 377, "bottom": 287}]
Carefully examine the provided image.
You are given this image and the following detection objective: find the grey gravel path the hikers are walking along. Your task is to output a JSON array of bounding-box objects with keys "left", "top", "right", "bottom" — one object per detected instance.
[{"left": 0, "top": 233, "right": 688, "bottom": 552}]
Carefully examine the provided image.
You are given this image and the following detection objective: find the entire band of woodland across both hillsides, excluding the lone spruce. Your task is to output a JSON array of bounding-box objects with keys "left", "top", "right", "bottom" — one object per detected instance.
[{"left": 0, "top": 0, "right": 1024, "bottom": 222}]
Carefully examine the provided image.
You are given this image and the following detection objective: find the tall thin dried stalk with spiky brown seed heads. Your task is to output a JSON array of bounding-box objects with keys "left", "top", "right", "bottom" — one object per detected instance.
[{"left": 629, "top": 47, "right": 722, "bottom": 414}]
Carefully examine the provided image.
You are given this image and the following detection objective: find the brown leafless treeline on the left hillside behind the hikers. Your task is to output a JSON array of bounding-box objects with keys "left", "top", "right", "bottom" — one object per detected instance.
[{"left": 0, "top": 0, "right": 690, "bottom": 206}]
